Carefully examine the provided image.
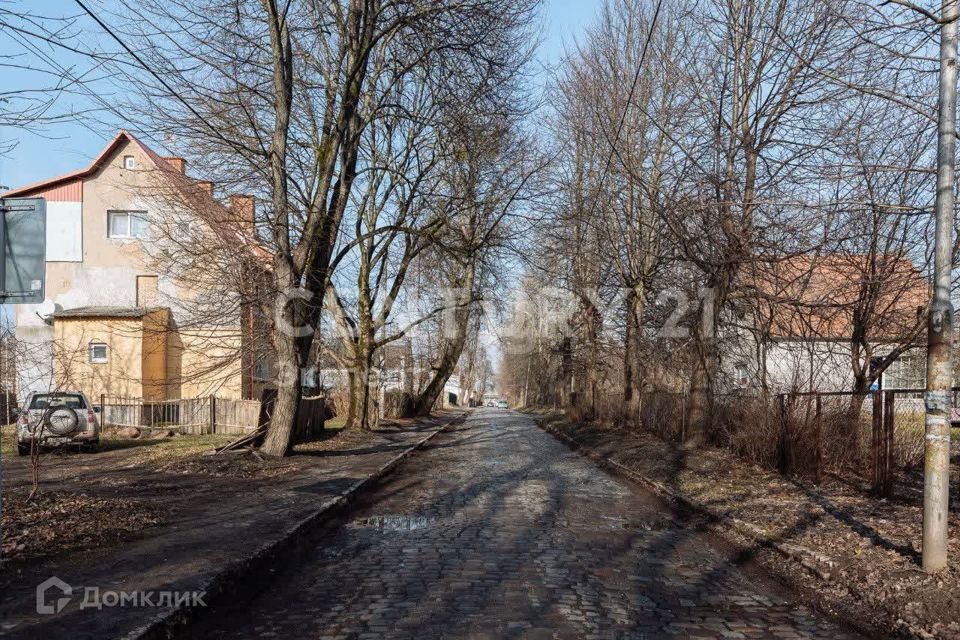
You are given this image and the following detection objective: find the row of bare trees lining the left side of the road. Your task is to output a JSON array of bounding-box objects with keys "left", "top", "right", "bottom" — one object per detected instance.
[{"left": 41, "top": 0, "right": 544, "bottom": 455}]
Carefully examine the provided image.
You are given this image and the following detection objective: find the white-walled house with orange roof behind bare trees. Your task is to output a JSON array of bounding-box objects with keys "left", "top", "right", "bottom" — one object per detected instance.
[{"left": 722, "top": 254, "right": 930, "bottom": 391}]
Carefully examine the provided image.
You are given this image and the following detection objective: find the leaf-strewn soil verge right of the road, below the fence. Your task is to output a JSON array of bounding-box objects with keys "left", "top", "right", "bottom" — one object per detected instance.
[{"left": 540, "top": 414, "right": 960, "bottom": 638}]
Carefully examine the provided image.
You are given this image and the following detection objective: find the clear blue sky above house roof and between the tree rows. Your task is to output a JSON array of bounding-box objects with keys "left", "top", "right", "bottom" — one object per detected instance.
[{"left": 0, "top": 0, "right": 600, "bottom": 191}]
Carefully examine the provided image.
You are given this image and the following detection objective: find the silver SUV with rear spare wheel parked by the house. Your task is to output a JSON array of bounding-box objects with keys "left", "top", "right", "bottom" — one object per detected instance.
[{"left": 17, "top": 391, "right": 100, "bottom": 456}]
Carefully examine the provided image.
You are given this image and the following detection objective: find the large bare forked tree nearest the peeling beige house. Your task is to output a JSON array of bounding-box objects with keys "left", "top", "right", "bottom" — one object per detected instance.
[{"left": 101, "top": 0, "right": 535, "bottom": 455}]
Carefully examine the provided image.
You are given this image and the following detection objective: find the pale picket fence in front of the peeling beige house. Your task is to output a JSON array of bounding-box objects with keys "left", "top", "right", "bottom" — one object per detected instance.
[{"left": 100, "top": 395, "right": 260, "bottom": 435}]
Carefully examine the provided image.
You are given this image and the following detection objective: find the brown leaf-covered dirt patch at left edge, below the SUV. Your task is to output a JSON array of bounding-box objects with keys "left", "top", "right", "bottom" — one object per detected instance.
[{"left": 3, "top": 490, "right": 163, "bottom": 560}]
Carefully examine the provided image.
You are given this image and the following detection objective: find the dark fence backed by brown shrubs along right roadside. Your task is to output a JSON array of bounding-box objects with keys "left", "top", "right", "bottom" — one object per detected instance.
[{"left": 592, "top": 388, "right": 944, "bottom": 497}]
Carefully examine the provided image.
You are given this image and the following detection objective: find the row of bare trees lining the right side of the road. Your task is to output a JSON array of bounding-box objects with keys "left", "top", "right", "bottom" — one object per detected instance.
[{"left": 501, "top": 0, "right": 937, "bottom": 443}]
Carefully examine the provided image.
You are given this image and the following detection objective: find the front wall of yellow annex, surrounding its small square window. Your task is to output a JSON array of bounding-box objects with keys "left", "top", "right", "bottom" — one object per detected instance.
[{"left": 54, "top": 318, "right": 143, "bottom": 402}]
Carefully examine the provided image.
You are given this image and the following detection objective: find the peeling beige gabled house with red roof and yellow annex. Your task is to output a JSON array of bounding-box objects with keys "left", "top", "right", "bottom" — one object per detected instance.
[{"left": 2, "top": 130, "right": 270, "bottom": 401}]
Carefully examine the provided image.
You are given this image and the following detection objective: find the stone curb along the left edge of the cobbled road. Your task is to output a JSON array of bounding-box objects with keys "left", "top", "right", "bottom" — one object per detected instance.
[{"left": 122, "top": 411, "right": 470, "bottom": 640}]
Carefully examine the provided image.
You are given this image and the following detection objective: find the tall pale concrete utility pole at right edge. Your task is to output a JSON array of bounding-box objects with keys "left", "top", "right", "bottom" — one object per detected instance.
[{"left": 923, "top": 0, "right": 957, "bottom": 572}]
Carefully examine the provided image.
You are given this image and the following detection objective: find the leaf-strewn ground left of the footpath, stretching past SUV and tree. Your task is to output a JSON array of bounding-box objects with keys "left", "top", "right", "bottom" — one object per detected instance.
[{"left": 0, "top": 421, "right": 428, "bottom": 564}]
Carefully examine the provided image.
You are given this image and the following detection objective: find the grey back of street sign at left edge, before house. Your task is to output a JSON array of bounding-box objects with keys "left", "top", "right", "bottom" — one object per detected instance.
[{"left": 0, "top": 198, "right": 47, "bottom": 304}]
